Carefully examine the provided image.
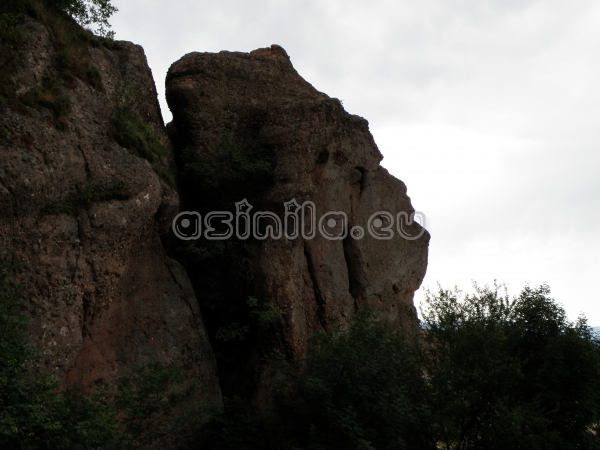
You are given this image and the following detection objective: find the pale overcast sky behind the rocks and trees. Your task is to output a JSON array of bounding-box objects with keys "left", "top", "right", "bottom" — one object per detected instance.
[{"left": 111, "top": 0, "right": 600, "bottom": 326}]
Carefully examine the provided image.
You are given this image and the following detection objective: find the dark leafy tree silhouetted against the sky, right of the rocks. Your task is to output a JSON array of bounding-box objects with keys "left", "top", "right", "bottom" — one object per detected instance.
[{"left": 422, "top": 285, "right": 600, "bottom": 450}]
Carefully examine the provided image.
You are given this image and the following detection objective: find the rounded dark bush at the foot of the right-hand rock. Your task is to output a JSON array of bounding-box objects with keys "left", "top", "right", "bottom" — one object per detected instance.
[{"left": 274, "top": 308, "right": 435, "bottom": 450}]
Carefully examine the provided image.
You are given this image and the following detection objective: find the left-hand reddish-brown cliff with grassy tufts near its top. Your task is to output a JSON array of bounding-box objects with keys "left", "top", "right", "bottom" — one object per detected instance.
[{"left": 0, "top": 14, "right": 222, "bottom": 405}]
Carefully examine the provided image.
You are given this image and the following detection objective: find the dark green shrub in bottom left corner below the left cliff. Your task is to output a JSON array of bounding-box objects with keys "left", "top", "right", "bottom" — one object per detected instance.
[{"left": 0, "top": 251, "right": 122, "bottom": 449}]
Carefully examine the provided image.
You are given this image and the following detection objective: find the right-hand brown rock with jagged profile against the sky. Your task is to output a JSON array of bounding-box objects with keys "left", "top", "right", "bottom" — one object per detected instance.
[{"left": 166, "top": 45, "right": 429, "bottom": 403}]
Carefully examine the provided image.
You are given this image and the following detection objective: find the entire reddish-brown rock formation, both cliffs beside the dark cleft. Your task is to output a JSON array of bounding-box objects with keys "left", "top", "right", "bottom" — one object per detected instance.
[{"left": 0, "top": 4, "right": 429, "bottom": 418}]
